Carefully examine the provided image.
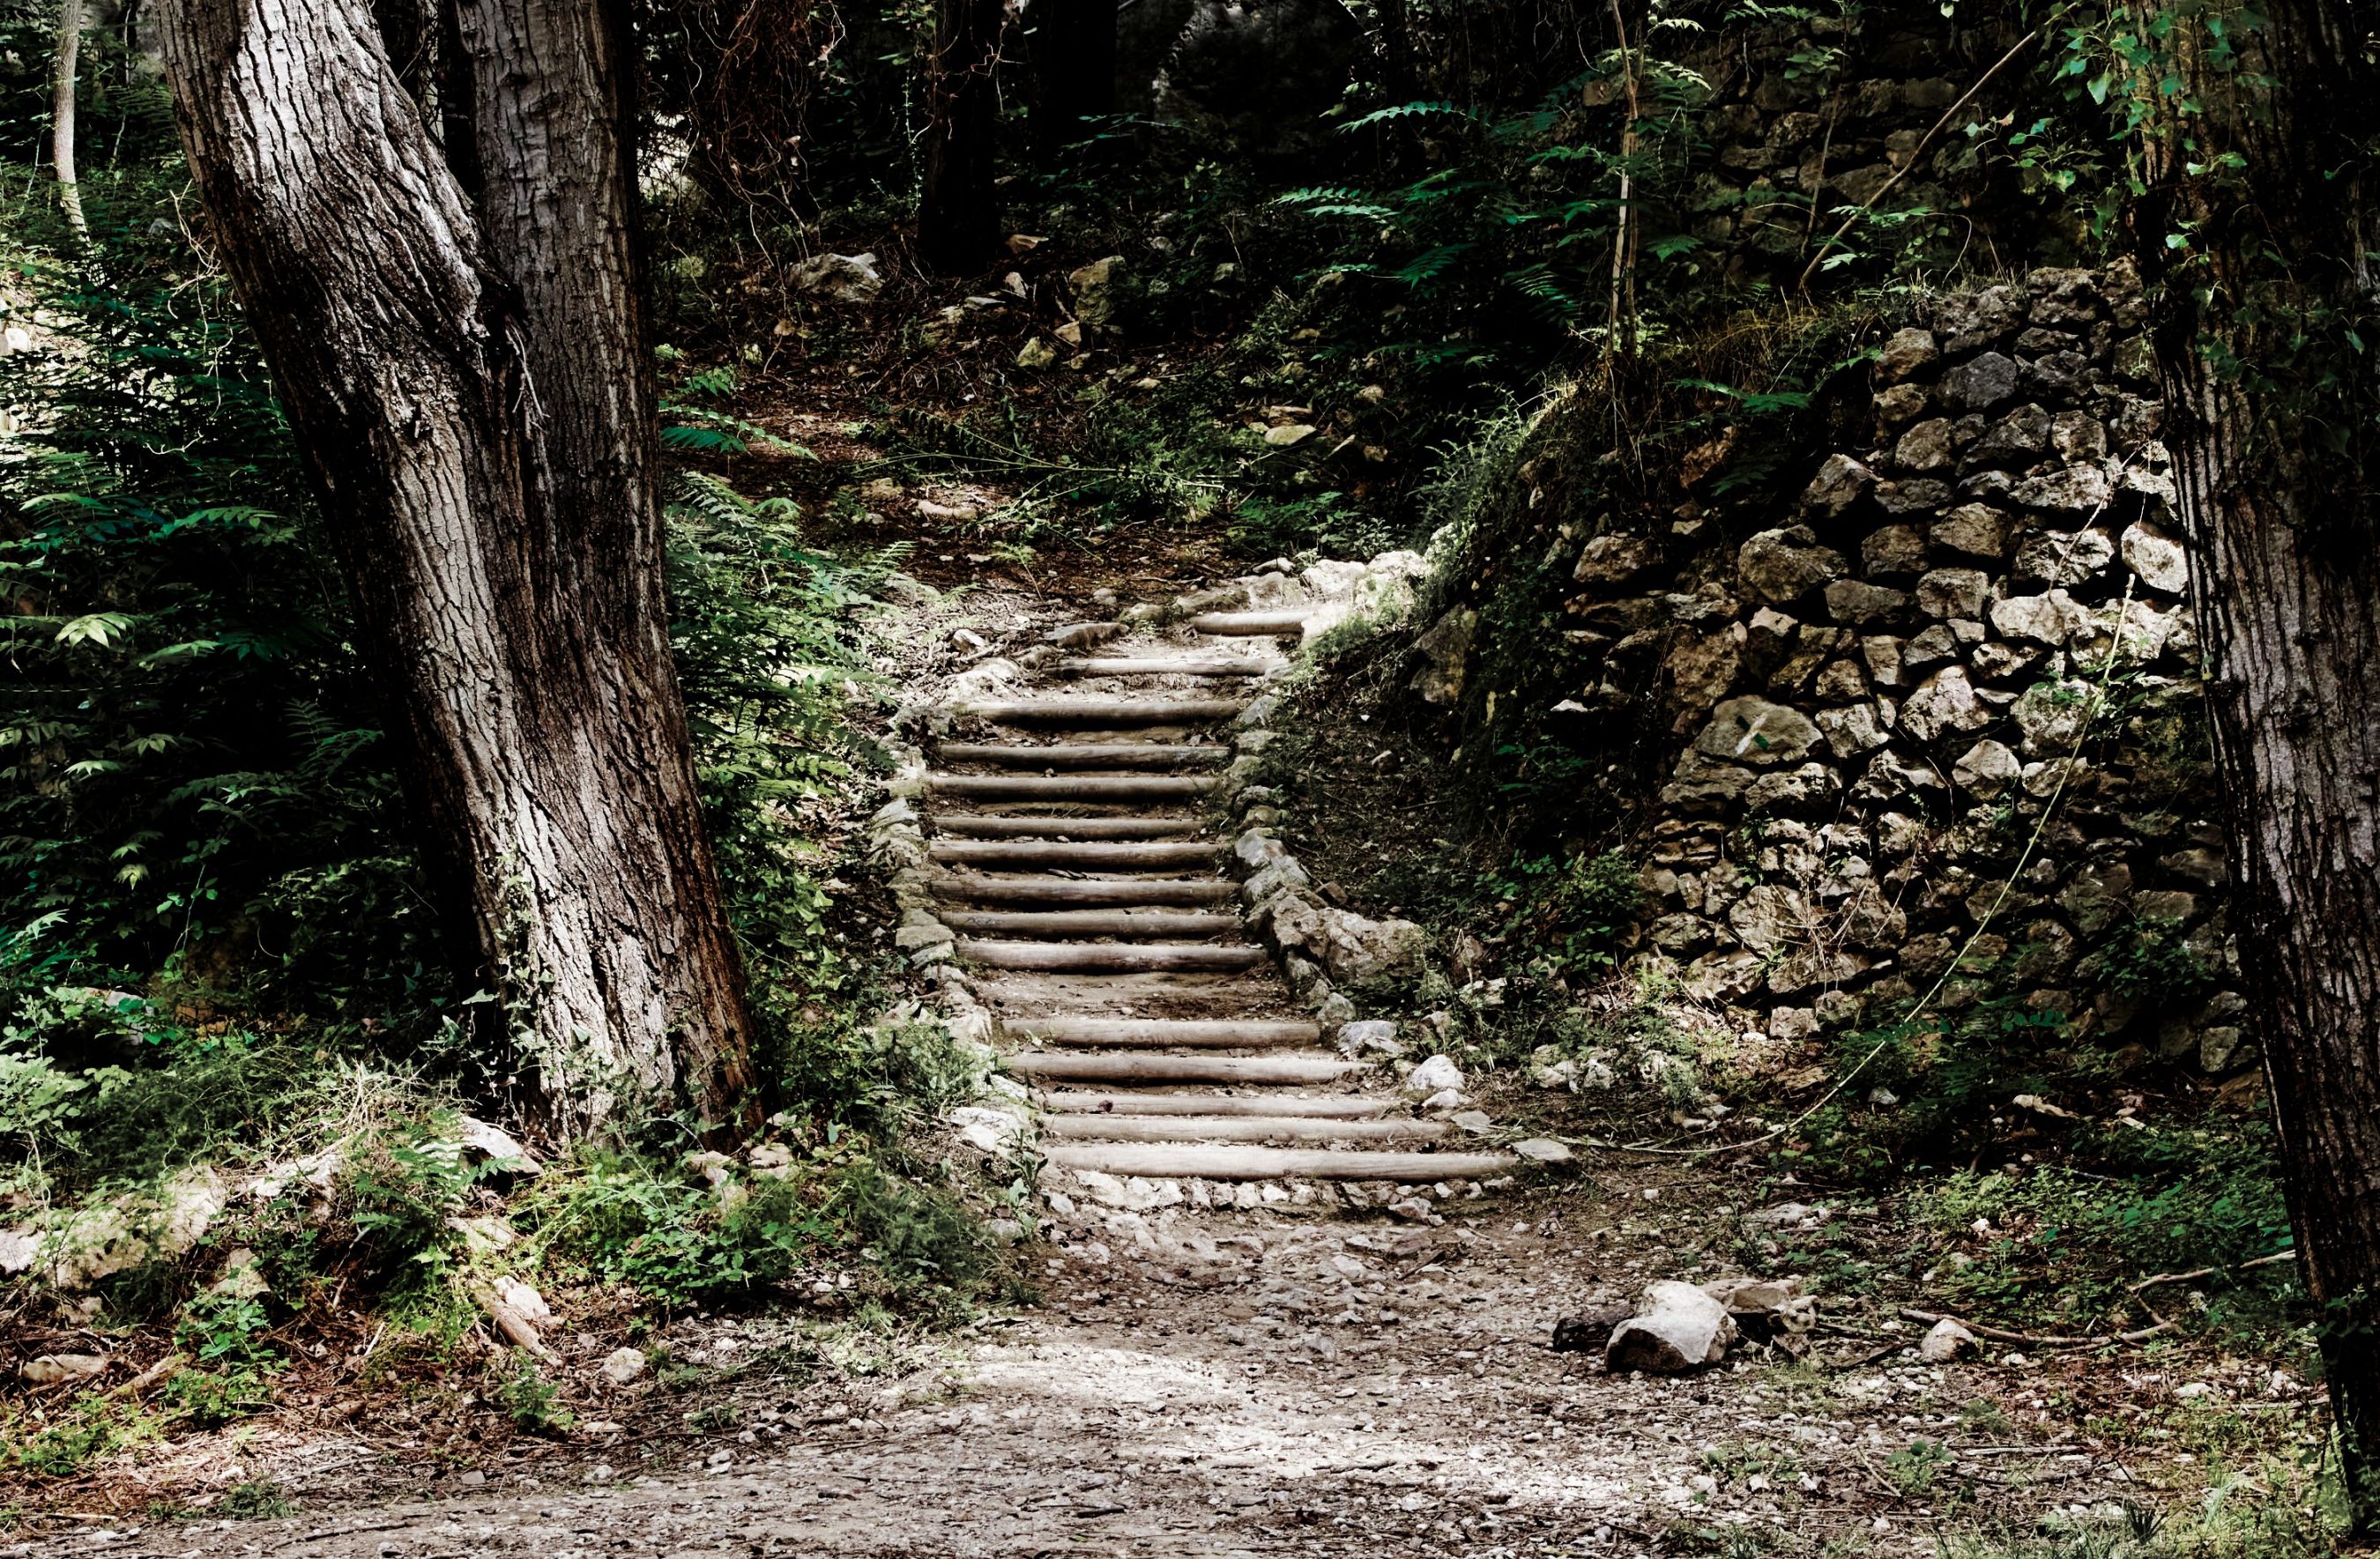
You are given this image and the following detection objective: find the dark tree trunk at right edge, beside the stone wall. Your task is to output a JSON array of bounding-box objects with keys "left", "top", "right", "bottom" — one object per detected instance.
[{"left": 2138, "top": 0, "right": 2380, "bottom": 1531}]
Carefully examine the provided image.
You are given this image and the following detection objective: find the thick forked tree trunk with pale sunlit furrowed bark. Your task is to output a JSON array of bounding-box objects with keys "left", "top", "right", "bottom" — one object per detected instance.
[{"left": 162, "top": 0, "right": 755, "bottom": 1135}]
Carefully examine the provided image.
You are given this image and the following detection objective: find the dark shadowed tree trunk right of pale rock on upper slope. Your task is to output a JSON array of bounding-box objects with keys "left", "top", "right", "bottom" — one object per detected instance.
[{"left": 917, "top": 0, "right": 1007, "bottom": 276}]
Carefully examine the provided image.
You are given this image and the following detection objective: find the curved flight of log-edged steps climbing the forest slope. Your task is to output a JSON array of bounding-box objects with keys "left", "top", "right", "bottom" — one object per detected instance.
[{"left": 921, "top": 609, "right": 1514, "bottom": 1183}]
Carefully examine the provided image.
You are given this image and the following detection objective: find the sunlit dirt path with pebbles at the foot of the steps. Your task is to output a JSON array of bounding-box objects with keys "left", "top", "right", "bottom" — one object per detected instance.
[{"left": 74, "top": 1181, "right": 2146, "bottom": 1559}]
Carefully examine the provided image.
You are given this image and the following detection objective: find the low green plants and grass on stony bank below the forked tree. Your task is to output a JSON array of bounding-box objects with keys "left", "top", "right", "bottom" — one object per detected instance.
[{"left": 0, "top": 1004, "right": 1019, "bottom": 1504}]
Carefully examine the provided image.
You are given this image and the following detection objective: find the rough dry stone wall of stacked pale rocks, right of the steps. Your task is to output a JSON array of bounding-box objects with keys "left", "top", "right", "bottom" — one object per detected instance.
[{"left": 1484, "top": 269, "right": 2254, "bottom": 1073}]
